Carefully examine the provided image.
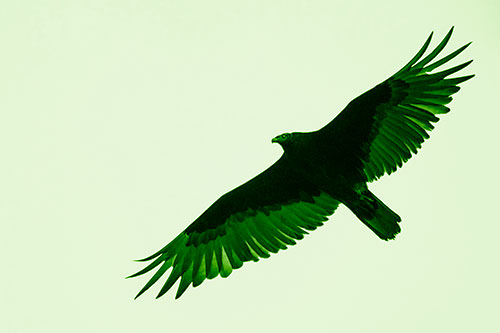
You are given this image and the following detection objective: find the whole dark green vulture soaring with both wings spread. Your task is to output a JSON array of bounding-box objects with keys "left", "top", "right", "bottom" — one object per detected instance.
[{"left": 127, "top": 27, "right": 474, "bottom": 299}]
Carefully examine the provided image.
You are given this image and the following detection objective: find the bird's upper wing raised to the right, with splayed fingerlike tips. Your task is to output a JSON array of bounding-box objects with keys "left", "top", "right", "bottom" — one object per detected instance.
[{"left": 315, "top": 28, "right": 474, "bottom": 181}]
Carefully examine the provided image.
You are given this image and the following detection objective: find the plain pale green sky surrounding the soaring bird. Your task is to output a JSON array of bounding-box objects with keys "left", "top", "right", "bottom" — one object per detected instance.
[{"left": 0, "top": 0, "right": 500, "bottom": 333}]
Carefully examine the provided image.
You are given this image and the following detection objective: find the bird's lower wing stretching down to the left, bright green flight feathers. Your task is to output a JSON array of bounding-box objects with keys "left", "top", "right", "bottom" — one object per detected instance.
[{"left": 130, "top": 157, "right": 339, "bottom": 298}]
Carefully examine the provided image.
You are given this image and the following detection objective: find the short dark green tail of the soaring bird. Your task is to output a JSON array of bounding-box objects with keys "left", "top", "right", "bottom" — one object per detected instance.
[{"left": 346, "top": 190, "right": 401, "bottom": 240}]
